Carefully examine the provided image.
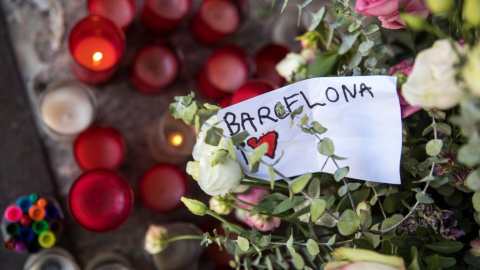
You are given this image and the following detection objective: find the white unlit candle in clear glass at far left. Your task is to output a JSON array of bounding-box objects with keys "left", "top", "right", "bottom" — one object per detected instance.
[{"left": 38, "top": 81, "right": 96, "bottom": 140}]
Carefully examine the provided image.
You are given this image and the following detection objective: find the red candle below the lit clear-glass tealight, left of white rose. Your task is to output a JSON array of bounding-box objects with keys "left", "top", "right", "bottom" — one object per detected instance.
[{"left": 140, "top": 164, "right": 188, "bottom": 212}]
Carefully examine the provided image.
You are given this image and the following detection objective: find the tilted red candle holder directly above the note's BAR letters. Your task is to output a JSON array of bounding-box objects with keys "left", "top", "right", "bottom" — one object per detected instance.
[{"left": 197, "top": 46, "right": 251, "bottom": 99}]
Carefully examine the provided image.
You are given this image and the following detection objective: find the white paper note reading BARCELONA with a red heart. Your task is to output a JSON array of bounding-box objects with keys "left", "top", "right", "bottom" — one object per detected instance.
[{"left": 217, "top": 76, "right": 402, "bottom": 184}]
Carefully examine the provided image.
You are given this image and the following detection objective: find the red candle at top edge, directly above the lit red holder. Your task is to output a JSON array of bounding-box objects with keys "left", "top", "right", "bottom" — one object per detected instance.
[{"left": 87, "top": 0, "right": 136, "bottom": 30}]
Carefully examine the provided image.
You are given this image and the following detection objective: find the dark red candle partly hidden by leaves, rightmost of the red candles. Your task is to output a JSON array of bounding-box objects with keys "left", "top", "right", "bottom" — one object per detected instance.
[{"left": 255, "top": 43, "right": 289, "bottom": 86}]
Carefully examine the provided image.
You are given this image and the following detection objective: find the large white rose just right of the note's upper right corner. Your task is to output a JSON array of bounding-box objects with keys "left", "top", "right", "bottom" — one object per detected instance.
[{"left": 402, "top": 39, "right": 462, "bottom": 110}]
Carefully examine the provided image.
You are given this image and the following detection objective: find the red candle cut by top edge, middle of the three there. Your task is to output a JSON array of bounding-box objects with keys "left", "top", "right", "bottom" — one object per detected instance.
[{"left": 140, "top": 0, "right": 192, "bottom": 35}]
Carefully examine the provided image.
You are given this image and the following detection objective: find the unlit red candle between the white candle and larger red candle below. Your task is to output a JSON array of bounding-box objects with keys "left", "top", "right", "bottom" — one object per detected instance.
[{"left": 73, "top": 126, "right": 126, "bottom": 171}]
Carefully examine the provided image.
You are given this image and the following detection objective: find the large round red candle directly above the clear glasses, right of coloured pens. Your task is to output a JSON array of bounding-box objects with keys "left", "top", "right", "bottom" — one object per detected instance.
[{"left": 68, "top": 169, "right": 133, "bottom": 232}]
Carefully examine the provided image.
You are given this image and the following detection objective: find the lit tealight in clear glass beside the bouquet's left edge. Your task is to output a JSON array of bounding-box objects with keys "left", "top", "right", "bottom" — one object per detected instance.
[{"left": 147, "top": 112, "right": 196, "bottom": 164}]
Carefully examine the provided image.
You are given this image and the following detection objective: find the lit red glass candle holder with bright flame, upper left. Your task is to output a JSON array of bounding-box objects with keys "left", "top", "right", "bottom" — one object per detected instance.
[{"left": 68, "top": 15, "right": 126, "bottom": 84}]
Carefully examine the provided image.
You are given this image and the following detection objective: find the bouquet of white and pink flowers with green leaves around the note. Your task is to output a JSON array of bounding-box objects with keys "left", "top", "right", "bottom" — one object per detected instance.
[{"left": 147, "top": 0, "right": 480, "bottom": 270}]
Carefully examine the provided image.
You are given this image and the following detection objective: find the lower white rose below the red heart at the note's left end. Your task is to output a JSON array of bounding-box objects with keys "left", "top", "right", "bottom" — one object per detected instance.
[{"left": 197, "top": 156, "right": 243, "bottom": 196}]
